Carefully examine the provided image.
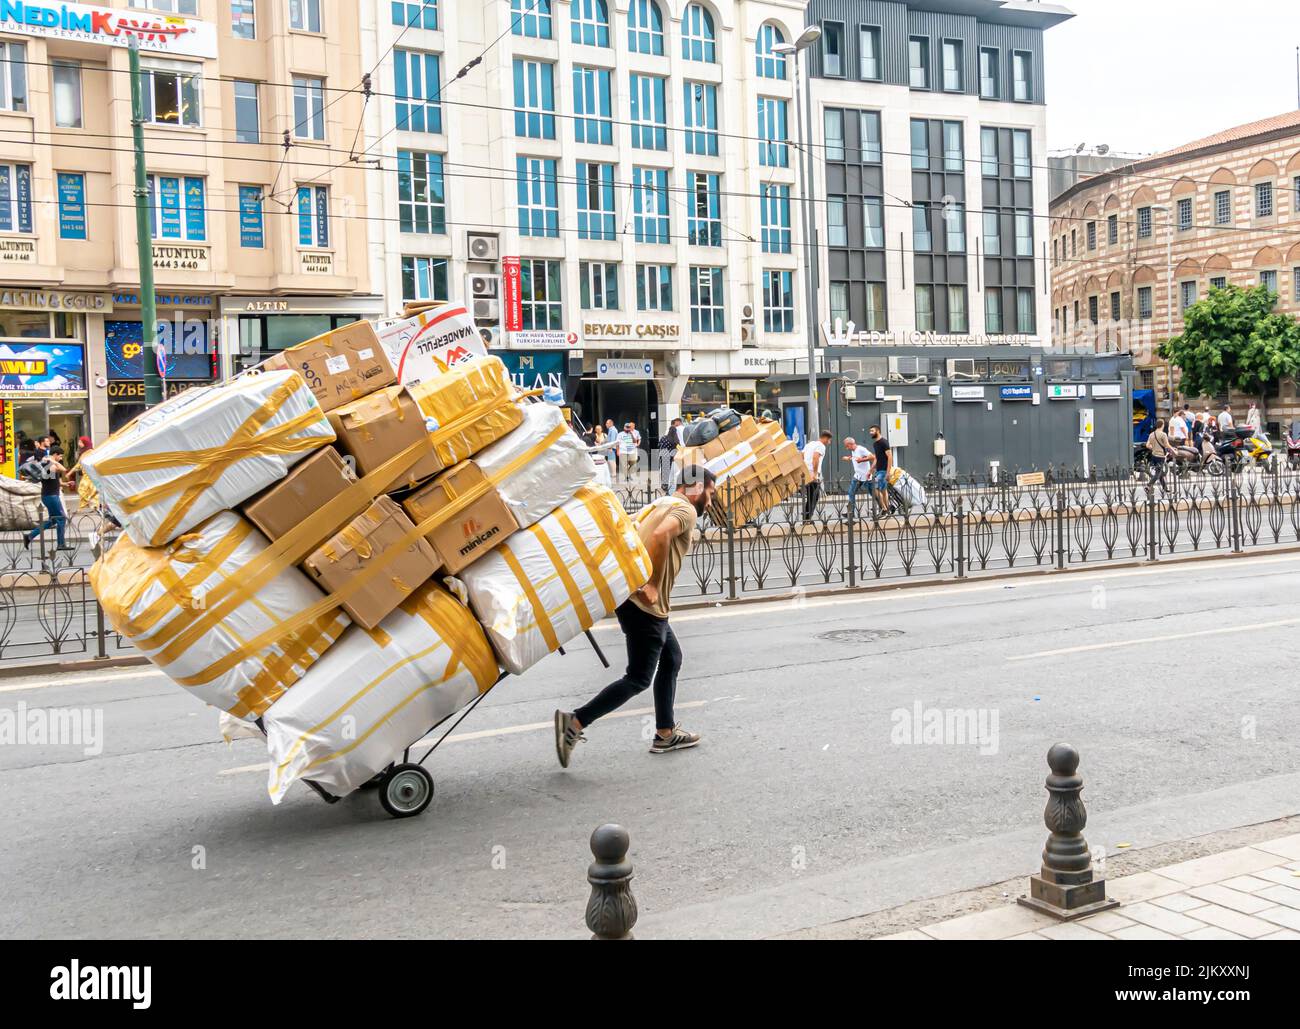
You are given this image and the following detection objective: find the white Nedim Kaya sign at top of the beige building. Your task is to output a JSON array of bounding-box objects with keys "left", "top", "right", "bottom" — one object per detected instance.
[{"left": 0, "top": 0, "right": 217, "bottom": 57}]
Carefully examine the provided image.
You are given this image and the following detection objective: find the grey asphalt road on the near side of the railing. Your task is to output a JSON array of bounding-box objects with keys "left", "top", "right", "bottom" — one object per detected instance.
[{"left": 0, "top": 553, "right": 1300, "bottom": 938}]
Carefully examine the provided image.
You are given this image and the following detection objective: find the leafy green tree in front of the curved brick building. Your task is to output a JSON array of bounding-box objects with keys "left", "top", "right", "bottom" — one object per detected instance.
[{"left": 1158, "top": 286, "right": 1300, "bottom": 418}]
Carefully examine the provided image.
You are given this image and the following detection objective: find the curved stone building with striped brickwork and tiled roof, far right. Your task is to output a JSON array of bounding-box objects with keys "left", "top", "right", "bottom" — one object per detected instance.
[{"left": 1050, "top": 112, "right": 1300, "bottom": 425}]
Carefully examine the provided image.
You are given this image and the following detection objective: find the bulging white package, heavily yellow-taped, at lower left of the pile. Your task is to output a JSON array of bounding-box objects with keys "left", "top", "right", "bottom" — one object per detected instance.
[{"left": 90, "top": 511, "right": 348, "bottom": 720}]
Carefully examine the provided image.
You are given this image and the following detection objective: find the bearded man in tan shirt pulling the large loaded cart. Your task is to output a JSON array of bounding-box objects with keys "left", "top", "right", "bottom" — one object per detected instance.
[{"left": 555, "top": 465, "right": 716, "bottom": 768}]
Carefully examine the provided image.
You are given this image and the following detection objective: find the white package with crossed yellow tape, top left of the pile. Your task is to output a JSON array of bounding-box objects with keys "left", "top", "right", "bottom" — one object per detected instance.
[{"left": 81, "top": 372, "right": 334, "bottom": 547}]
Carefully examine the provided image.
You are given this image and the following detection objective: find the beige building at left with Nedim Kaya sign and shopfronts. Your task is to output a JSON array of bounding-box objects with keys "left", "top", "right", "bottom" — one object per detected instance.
[{"left": 0, "top": 0, "right": 382, "bottom": 461}]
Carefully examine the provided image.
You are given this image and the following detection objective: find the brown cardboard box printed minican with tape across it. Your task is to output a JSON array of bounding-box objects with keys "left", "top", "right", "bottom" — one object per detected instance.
[{"left": 402, "top": 461, "right": 519, "bottom": 576}]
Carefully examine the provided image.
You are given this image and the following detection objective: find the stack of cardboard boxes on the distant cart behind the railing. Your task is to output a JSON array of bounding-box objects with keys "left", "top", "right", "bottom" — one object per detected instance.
[{"left": 676, "top": 414, "right": 811, "bottom": 525}]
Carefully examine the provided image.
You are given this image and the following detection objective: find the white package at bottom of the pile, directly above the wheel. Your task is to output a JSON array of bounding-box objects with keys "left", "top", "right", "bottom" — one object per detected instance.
[{"left": 263, "top": 582, "right": 498, "bottom": 804}]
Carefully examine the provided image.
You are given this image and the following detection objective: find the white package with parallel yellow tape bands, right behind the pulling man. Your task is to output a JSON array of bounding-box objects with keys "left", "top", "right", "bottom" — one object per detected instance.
[{"left": 459, "top": 486, "right": 660, "bottom": 674}]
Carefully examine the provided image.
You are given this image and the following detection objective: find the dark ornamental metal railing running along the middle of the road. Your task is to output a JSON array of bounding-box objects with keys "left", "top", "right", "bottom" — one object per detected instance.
[{"left": 0, "top": 465, "right": 1300, "bottom": 664}]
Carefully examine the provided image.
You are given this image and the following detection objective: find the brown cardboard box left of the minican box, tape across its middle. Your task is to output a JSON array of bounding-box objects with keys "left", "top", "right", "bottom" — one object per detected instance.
[{"left": 303, "top": 496, "right": 438, "bottom": 629}]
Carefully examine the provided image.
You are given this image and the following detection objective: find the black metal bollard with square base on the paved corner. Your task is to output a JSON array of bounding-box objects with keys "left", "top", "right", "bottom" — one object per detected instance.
[{"left": 1019, "top": 743, "right": 1119, "bottom": 921}]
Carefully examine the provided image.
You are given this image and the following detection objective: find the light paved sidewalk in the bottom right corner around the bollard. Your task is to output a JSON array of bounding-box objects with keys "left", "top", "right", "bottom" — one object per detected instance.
[{"left": 875, "top": 833, "right": 1300, "bottom": 939}]
